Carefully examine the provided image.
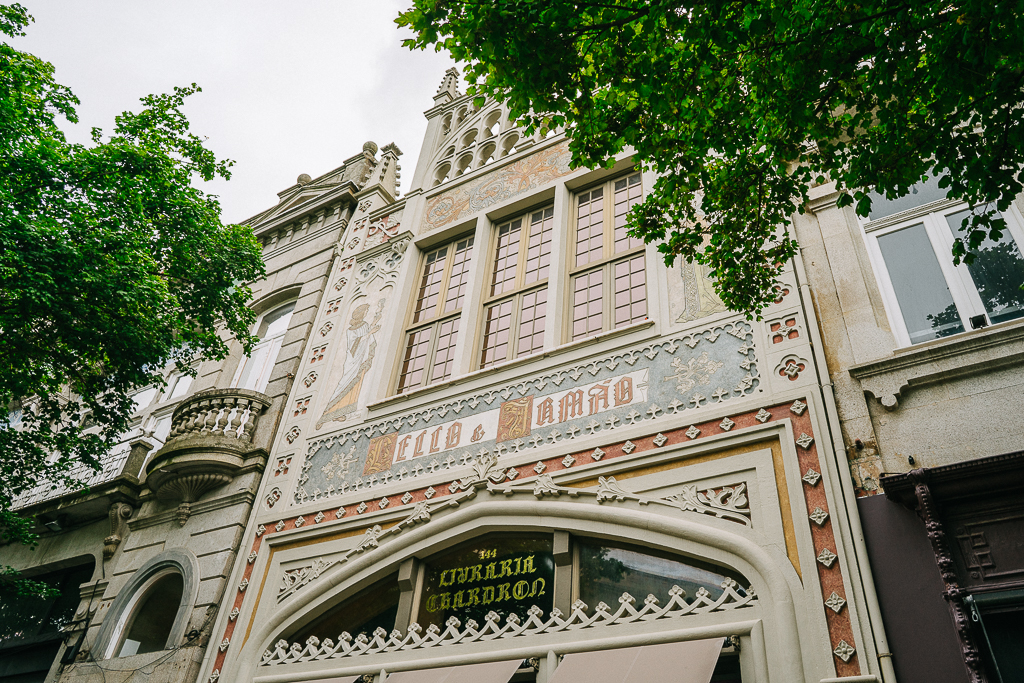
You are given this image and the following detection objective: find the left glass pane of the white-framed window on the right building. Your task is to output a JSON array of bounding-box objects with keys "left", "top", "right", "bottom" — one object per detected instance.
[{"left": 879, "top": 223, "right": 964, "bottom": 344}]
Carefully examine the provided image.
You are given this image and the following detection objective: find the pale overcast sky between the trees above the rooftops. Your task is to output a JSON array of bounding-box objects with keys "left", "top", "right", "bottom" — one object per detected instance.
[{"left": 13, "top": 0, "right": 453, "bottom": 222}]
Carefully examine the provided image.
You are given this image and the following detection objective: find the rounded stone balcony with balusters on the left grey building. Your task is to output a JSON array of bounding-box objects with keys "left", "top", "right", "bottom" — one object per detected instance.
[{"left": 145, "top": 389, "right": 271, "bottom": 525}]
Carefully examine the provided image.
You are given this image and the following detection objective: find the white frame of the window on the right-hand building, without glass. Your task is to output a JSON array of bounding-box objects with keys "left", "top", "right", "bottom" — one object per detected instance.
[{"left": 860, "top": 200, "right": 1024, "bottom": 348}]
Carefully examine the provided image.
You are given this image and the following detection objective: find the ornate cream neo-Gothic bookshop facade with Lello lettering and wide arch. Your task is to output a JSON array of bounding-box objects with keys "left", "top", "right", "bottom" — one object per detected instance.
[{"left": 188, "top": 73, "right": 884, "bottom": 683}]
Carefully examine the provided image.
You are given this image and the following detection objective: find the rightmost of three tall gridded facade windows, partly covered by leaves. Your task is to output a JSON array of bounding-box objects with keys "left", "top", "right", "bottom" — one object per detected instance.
[{"left": 569, "top": 173, "right": 647, "bottom": 339}]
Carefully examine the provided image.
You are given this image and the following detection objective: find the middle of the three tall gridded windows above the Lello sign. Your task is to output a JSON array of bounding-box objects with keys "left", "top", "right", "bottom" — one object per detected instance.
[{"left": 480, "top": 207, "right": 554, "bottom": 368}]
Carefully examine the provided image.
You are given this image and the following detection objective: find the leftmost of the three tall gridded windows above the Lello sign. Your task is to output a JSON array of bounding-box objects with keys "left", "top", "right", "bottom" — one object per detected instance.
[{"left": 398, "top": 237, "right": 473, "bottom": 393}]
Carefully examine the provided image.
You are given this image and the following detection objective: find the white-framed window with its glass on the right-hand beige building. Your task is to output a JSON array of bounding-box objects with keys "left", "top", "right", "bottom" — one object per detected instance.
[{"left": 865, "top": 181, "right": 1024, "bottom": 344}]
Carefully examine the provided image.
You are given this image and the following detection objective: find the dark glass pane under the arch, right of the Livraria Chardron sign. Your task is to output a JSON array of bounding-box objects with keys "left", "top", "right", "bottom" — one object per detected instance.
[{"left": 580, "top": 542, "right": 750, "bottom": 609}]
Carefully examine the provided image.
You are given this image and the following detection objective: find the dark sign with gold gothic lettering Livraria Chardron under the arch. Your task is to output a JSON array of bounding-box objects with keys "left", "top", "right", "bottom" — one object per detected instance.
[{"left": 418, "top": 537, "right": 555, "bottom": 628}]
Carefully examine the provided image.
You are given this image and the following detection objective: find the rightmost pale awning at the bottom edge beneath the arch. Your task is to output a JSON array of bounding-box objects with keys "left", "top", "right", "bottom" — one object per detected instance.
[{"left": 550, "top": 638, "right": 722, "bottom": 683}]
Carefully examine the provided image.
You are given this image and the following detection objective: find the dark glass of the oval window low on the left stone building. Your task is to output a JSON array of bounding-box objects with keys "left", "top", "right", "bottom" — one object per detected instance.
[{"left": 109, "top": 569, "right": 184, "bottom": 657}]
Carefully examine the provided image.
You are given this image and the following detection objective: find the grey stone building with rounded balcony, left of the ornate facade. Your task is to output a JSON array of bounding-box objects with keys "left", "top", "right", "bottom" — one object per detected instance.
[{"left": 0, "top": 144, "right": 395, "bottom": 683}]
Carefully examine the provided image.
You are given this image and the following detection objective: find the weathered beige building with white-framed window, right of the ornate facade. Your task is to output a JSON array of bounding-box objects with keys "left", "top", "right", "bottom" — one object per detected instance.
[{"left": 794, "top": 157, "right": 1024, "bottom": 683}]
